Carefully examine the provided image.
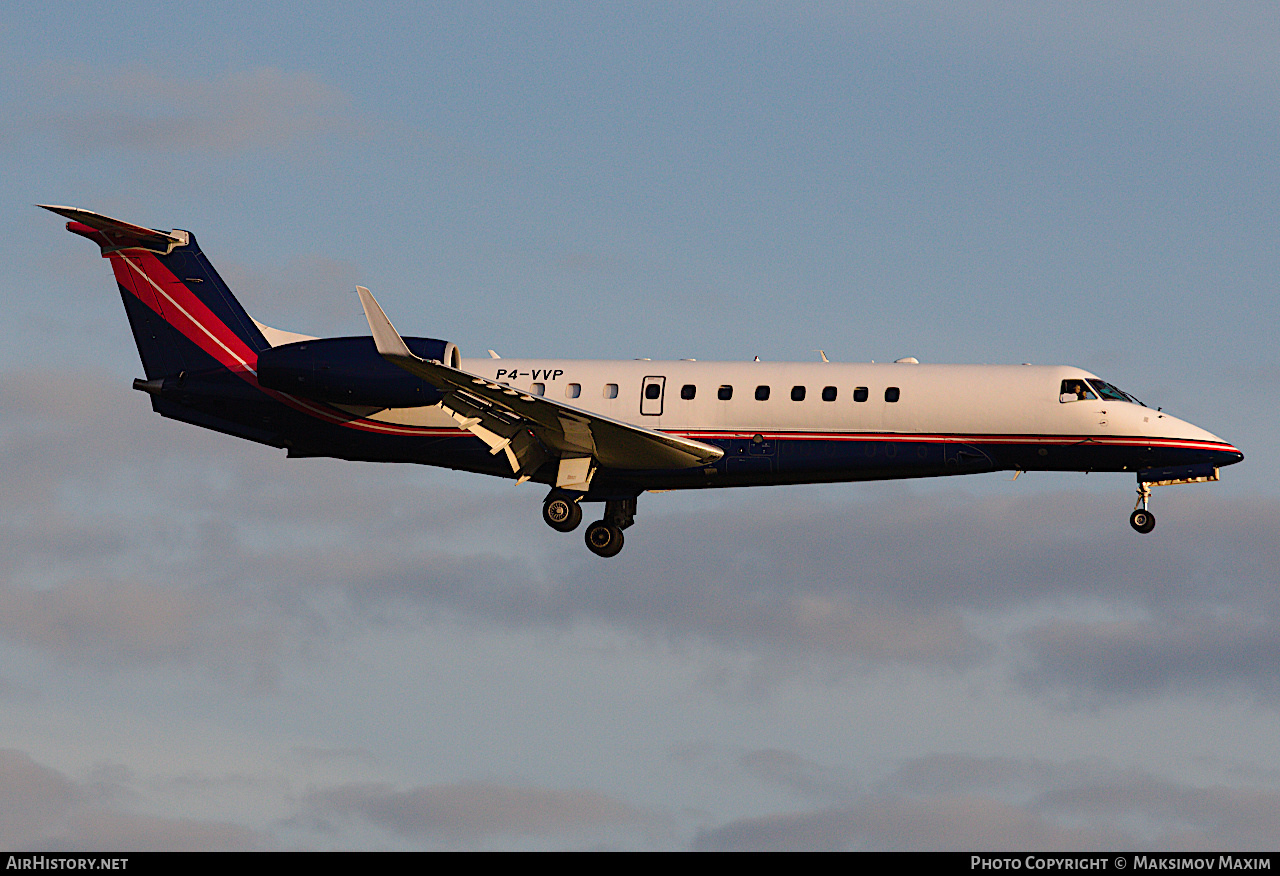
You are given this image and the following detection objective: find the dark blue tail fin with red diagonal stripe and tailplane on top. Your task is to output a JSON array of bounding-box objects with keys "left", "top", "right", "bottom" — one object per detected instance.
[{"left": 38, "top": 204, "right": 270, "bottom": 380}]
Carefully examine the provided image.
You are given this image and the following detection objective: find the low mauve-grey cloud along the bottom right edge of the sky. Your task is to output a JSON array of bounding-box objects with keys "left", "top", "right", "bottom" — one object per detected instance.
[{"left": 694, "top": 754, "right": 1280, "bottom": 852}]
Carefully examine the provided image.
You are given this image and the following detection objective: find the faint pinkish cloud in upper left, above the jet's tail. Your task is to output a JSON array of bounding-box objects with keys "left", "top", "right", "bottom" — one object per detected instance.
[{"left": 21, "top": 67, "right": 360, "bottom": 154}]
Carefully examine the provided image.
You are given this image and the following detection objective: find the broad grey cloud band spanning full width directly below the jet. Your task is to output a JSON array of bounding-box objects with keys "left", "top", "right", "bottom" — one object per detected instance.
[{"left": 0, "top": 373, "right": 1280, "bottom": 697}]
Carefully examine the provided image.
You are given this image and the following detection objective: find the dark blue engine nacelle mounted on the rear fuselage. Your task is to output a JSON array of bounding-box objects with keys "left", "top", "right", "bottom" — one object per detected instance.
[{"left": 257, "top": 337, "right": 462, "bottom": 407}]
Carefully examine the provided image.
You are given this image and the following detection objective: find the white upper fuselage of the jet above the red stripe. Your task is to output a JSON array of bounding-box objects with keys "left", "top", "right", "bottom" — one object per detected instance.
[{"left": 360, "top": 359, "right": 1225, "bottom": 455}]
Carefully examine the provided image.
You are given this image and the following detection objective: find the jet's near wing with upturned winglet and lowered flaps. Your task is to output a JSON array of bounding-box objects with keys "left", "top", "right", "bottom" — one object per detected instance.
[{"left": 356, "top": 286, "right": 724, "bottom": 491}]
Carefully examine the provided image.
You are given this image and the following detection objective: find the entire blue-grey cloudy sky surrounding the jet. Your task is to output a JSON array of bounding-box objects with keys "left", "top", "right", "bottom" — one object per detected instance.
[{"left": 0, "top": 0, "right": 1280, "bottom": 850}]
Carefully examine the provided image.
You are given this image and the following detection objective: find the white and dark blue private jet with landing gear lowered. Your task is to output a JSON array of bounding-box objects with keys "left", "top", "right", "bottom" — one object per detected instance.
[{"left": 38, "top": 205, "right": 1244, "bottom": 557}]
